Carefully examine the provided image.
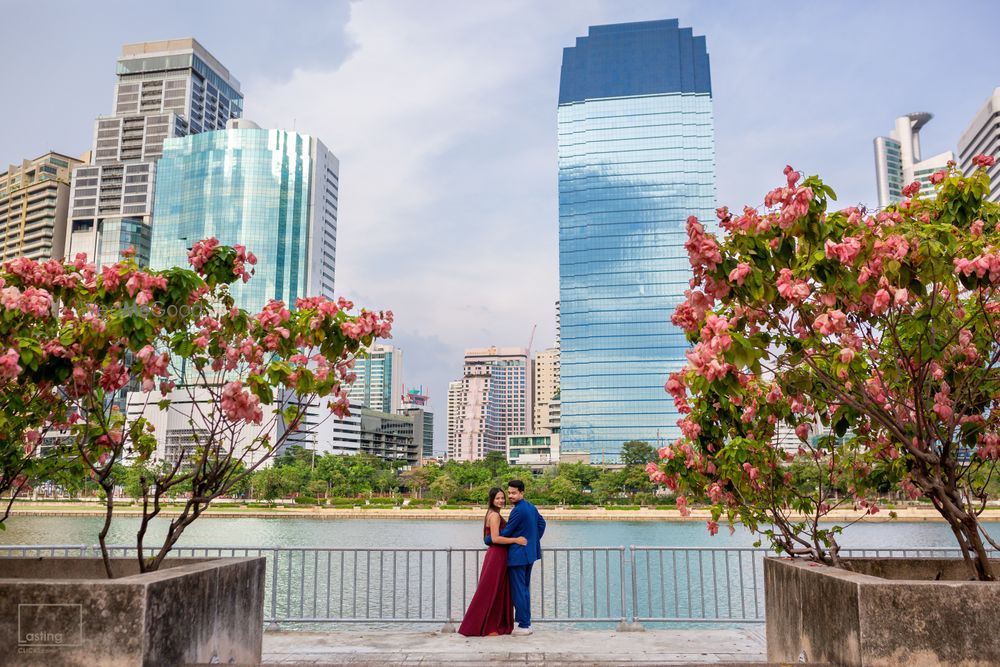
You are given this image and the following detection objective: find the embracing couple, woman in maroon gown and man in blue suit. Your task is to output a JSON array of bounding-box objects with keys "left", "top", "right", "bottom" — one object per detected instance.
[{"left": 458, "top": 479, "right": 545, "bottom": 637}]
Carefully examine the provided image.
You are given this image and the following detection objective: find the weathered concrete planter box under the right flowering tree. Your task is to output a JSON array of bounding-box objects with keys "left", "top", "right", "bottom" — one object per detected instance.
[{"left": 764, "top": 558, "right": 1000, "bottom": 667}]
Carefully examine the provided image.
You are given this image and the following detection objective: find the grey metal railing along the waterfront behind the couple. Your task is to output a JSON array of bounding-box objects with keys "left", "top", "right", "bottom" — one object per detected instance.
[{"left": 0, "top": 544, "right": 992, "bottom": 629}]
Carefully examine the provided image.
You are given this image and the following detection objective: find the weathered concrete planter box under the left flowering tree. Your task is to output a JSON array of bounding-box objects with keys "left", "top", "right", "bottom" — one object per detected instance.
[{"left": 0, "top": 557, "right": 266, "bottom": 667}]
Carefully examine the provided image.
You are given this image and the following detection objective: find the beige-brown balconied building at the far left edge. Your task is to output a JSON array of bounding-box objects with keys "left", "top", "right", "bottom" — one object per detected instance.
[{"left": 0, "top": 153, "right": 83, "bottom": 262}]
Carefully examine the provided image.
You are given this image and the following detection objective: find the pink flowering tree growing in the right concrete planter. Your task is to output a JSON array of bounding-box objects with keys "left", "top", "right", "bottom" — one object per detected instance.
[{"left": 649, "top": 156, "right": 1000, "bottom": 580}]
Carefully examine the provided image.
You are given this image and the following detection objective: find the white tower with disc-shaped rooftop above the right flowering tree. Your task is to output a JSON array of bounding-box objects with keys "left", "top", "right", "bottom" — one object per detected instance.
[{"left": 874, "top": 111, "right": 955, "bottom": 208}]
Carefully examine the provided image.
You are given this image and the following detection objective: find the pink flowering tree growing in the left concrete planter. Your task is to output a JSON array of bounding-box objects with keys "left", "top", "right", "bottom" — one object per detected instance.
[{"left": 0, "top": 239, "right": 392, "bottom": 577}]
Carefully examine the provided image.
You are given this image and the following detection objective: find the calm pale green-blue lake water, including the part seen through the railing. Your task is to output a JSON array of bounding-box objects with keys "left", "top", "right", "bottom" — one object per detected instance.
[{"left": 0, "top": 516, "right": 1000, "bottom": 629}]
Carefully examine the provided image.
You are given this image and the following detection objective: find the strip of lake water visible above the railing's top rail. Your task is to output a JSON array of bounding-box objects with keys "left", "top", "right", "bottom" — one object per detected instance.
[{"left": 0, "top": 516, "right": 1000, "bottom": 549}]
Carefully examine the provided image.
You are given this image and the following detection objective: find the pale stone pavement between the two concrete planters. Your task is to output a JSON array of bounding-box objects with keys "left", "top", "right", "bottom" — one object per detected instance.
[{"left": 263, "top": 626, "right": 766, "bottom": 667}]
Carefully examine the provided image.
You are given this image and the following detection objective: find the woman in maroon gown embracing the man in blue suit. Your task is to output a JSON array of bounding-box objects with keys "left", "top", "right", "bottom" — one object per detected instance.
[{"left": 458, "top": 488, "right": 527, "bottom": 637}]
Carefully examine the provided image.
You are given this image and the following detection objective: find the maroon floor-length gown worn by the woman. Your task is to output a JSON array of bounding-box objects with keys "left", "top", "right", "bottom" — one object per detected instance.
[{"left": 458, "top": 517, "right": 514, "bottom": 637}]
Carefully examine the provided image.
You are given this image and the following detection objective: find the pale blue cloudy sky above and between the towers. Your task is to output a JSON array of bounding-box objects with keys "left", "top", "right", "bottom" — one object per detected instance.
[{"left": 0, "top": 0, "right": 1000, "bottom": 451}]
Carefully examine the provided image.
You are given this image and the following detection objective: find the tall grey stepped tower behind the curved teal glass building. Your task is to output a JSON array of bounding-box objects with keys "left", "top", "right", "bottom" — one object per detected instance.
[{"left": 67, "top": 38, "right": 243, "bottom": 266}]
